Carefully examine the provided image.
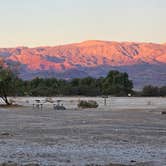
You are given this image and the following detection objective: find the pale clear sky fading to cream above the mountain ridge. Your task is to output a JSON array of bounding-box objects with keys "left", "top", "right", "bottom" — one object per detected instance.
[{"left": 0, "top": 0, "right": 166, "bottom": 48}]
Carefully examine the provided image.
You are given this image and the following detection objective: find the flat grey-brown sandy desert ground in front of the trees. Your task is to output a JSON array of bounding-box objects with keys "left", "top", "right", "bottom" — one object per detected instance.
[{"left": 0, "top": 97, "right": 166, "bottom": 166}]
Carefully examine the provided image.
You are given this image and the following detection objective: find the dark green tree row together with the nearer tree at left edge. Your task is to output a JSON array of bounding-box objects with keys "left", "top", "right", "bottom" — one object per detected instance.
[{"left": 0, "top": 67, "right": 133, "bottom": 104}]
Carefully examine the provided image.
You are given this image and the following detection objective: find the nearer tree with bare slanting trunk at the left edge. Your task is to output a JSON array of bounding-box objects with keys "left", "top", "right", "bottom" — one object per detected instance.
[{"left": 0, "top": 66, "right": 17, "bottom": 105}]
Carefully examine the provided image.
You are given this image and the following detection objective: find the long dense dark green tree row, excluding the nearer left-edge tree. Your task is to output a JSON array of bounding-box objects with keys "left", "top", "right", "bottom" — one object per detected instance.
[{"left": 16, "top": 71, "right": 133, "bottom": 96}]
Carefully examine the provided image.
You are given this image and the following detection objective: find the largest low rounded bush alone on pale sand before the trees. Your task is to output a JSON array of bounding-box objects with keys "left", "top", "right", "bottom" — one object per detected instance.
[{"left": 78, "top": 100, "right": 99, "bottom": 108}]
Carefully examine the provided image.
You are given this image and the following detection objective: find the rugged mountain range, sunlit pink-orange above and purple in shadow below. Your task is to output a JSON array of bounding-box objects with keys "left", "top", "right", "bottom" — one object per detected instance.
[{"left": 0, "top": 40, "right": 166, "bottom": 88}]
